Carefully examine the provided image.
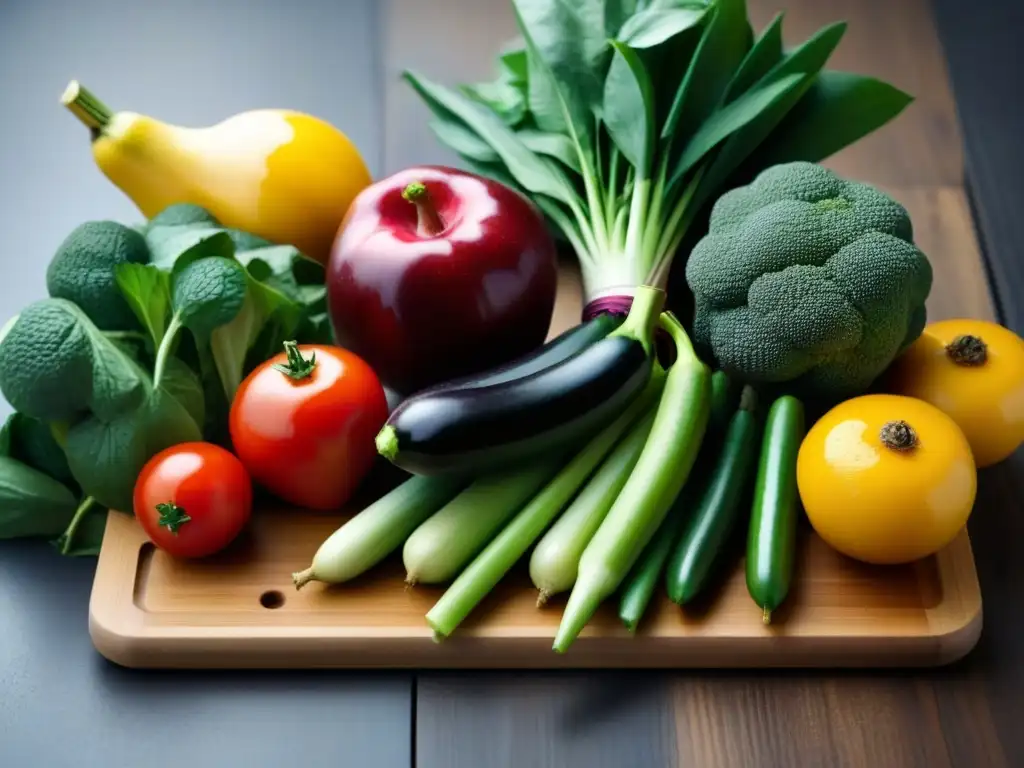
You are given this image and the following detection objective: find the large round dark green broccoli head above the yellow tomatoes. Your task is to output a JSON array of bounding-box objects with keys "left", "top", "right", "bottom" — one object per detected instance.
[{"left": 686, "top": 162, "right": 932, "bottom": 401}]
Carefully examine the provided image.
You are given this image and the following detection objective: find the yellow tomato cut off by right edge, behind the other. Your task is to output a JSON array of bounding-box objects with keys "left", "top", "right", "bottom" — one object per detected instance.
[{"left": 886, "top": 319, "right": 1024, "bottom": 467}]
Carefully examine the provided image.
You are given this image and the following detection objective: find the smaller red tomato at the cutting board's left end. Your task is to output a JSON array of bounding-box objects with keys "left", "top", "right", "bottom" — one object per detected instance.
[{"left": 134, "top": 442, "right": 253, "bottom": 558}]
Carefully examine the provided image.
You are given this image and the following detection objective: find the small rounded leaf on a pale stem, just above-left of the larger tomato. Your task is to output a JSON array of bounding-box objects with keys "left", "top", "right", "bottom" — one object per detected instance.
[{"left": 171, "top": 256, "right": 247, "bottom": 338}]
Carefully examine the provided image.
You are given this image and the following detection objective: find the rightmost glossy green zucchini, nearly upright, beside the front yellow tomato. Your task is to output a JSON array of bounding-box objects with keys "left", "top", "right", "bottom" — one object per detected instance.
[{"left": 746, "top": 395, "right": 804, "bottom": 624}]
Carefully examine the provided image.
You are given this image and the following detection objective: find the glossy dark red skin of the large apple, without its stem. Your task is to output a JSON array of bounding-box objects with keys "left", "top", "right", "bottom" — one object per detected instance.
[{"left": 327, "top": 166, "right": 557, "bottom": 394}]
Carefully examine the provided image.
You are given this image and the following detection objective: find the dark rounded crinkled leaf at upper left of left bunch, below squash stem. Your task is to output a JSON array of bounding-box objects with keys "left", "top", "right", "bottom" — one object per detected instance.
[{"left": 46, "top": 221, "right": 150, "bottom": 331}]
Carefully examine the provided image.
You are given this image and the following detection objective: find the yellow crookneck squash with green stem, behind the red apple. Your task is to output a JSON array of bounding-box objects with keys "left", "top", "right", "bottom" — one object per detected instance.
[{"left": 61, "top": 81, "right": 372, "bottom": 263}]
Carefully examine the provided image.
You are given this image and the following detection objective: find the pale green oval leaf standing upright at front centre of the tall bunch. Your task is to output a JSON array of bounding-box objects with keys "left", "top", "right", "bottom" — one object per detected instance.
[{"left": 602, "top": 40, "right": 654, "bottom": 178}]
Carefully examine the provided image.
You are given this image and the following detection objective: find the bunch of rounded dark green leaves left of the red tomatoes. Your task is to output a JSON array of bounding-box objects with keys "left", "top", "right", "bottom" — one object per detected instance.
[{"left": 0, "top": 205, "right": 331, "bottom": 555}]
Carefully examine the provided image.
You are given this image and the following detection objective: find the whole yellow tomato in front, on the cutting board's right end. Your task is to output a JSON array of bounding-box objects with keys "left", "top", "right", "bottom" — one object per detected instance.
[{"left": 797, "top": 394, "right": 977, "bottom": 563}]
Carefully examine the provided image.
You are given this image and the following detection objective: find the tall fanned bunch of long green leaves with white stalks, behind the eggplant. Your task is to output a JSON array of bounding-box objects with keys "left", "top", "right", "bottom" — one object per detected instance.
[{"left": 404, "top": 0, "right": 910, "bottom": 307}]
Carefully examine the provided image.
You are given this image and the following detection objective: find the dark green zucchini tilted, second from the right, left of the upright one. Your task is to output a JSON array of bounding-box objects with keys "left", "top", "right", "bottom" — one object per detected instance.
[{"left": 666, "top": 387, "right": 758, "bottom": 605}]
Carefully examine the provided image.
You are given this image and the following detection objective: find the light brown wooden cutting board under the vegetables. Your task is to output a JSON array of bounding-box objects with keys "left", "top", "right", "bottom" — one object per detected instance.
[{"left": 89, "top": 270, "right": 981, "bottom": 669}]
